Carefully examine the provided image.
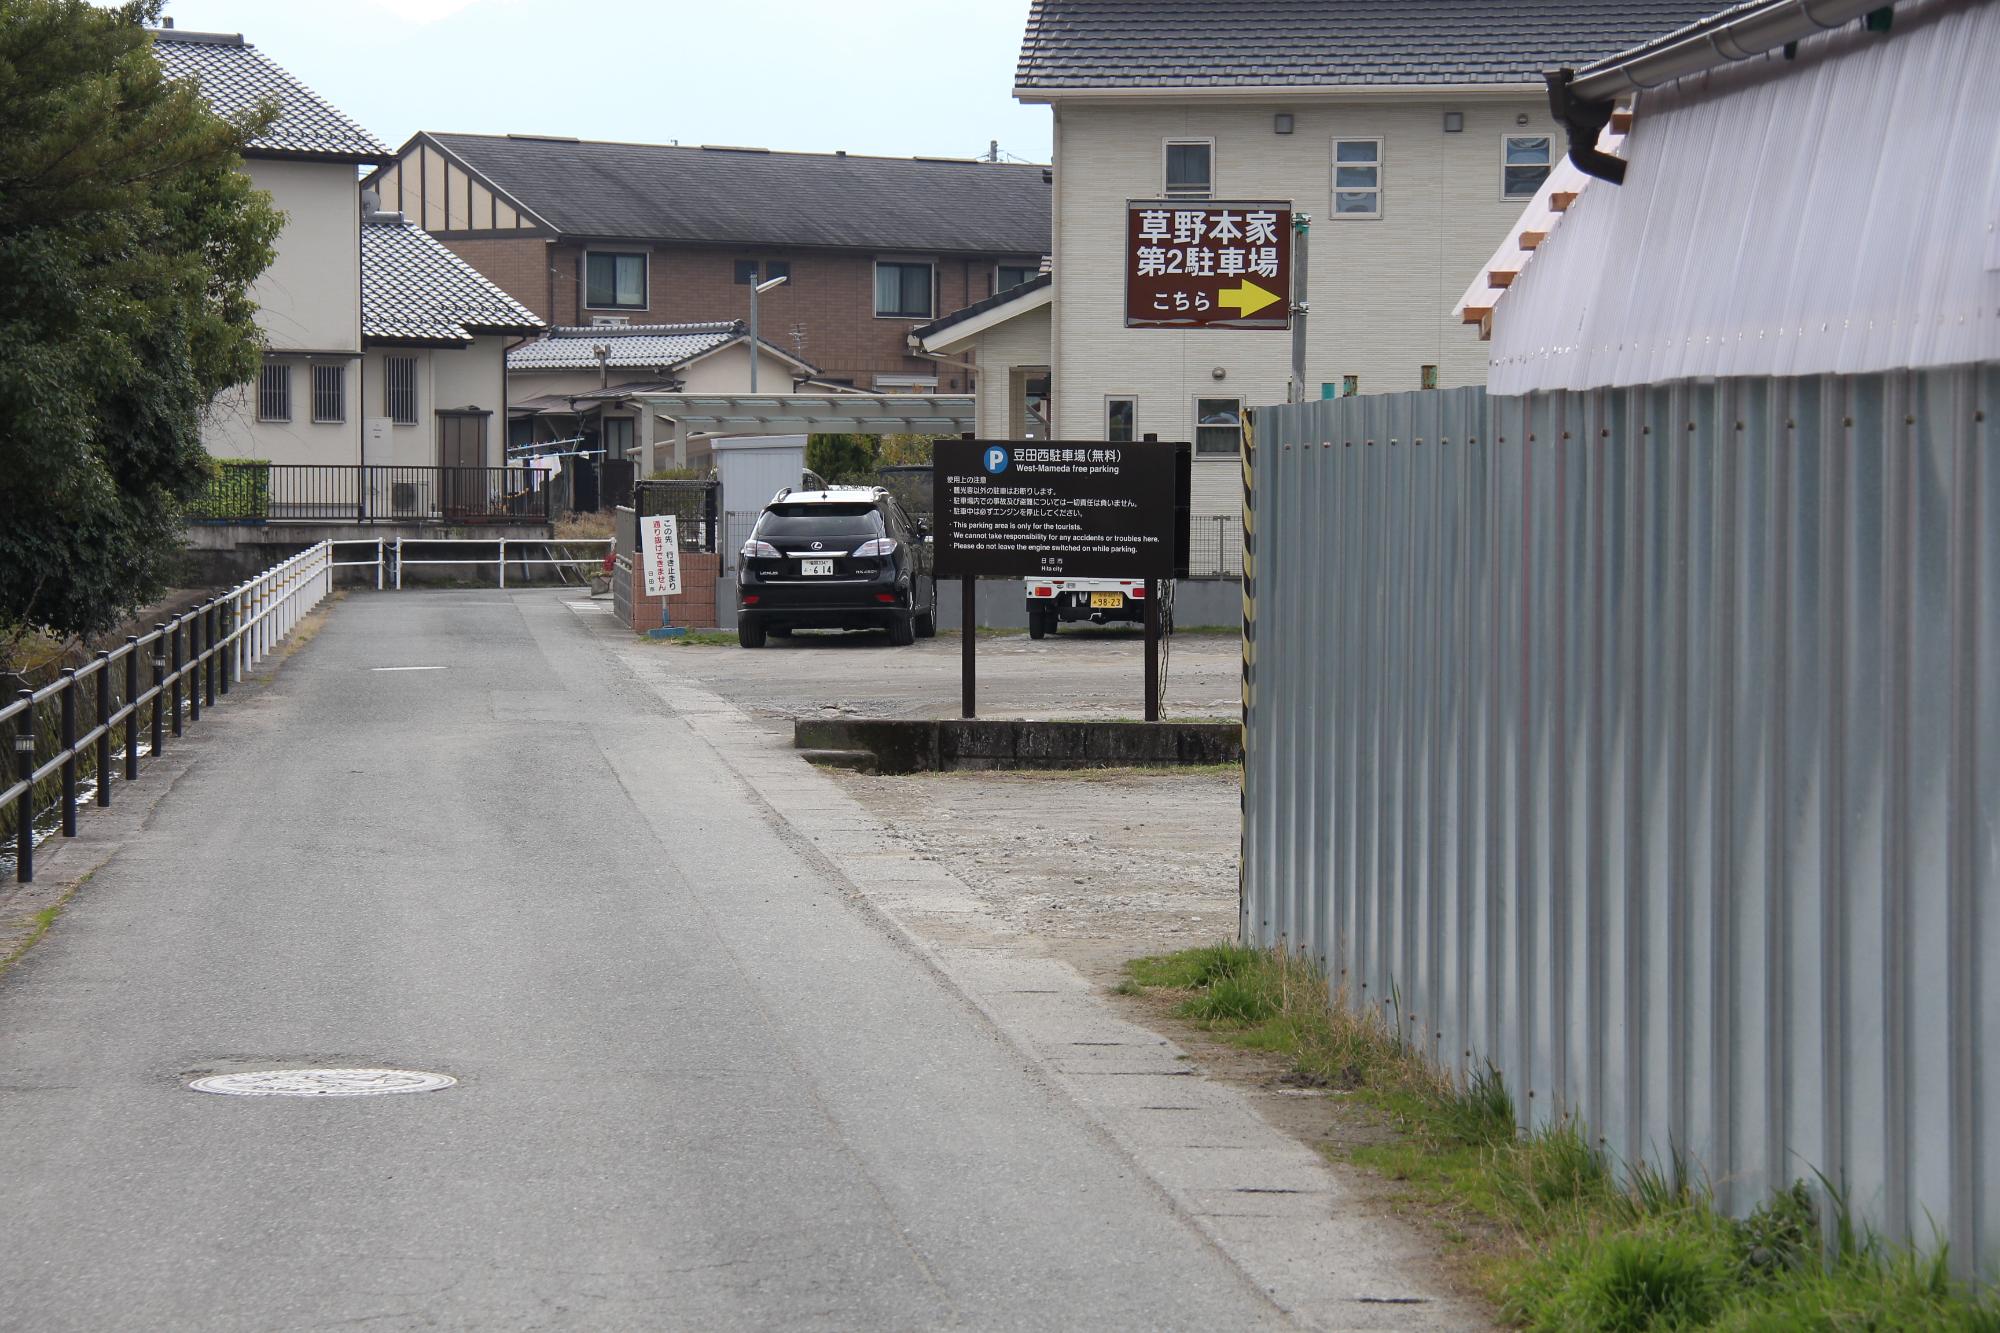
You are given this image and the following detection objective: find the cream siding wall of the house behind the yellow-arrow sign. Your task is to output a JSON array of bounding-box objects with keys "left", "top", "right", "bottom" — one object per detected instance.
[{"left": 1056, "top": 94, "right": 1564, "bottom": 512}]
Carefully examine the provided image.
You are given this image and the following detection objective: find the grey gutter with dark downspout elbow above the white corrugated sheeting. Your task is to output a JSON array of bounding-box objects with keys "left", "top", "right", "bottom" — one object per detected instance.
[{"left": 1542, "top": 0, "right": 1894, "bottom": 184}]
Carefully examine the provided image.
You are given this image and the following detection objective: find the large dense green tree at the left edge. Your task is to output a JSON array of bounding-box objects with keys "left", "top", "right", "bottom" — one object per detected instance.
[{"left": 0, "top": 0, "right": 284, "bottom": 656}]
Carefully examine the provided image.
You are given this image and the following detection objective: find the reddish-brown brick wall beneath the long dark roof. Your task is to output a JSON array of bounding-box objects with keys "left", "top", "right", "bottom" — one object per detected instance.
[{"left": 446, "top": 238, "right": 1040, "bottom": 392}]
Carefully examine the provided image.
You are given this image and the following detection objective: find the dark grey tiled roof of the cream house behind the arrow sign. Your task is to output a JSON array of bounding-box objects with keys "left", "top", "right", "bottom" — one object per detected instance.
[{"left": 1014, "top": 0, "right": 1718, "bottom": 92}]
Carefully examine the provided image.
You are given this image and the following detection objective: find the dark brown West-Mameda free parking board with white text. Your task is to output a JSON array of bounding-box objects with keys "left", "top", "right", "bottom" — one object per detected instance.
[{"left": 932, "top": 440, "right": 1188, "bottom": 578}]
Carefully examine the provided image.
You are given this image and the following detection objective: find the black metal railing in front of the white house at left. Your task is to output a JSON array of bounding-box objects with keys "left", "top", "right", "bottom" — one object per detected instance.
[{"left": 190, "top": 462, "right": 548, "bottom": 524}]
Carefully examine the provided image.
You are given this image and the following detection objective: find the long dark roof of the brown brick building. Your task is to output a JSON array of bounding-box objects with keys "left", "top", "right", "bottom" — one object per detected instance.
[{"left": 424, "top": 134, "right": 1050, "bottom": 254}]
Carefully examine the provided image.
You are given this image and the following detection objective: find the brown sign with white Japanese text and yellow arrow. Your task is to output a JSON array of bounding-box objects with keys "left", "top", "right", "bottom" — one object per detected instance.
[{"left": 1126, "top": 198, "right": 1292, "bottom": 328}]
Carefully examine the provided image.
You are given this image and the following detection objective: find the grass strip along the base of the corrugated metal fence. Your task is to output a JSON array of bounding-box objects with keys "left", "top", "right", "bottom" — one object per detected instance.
[{"left": 1116, "top": 945, "right": 2000, "bottom": 1333}]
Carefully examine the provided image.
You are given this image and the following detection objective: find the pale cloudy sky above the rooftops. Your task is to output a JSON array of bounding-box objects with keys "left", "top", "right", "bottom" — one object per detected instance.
[{"left": 154, "top": 0, "right": 1050, "bottom": 162}]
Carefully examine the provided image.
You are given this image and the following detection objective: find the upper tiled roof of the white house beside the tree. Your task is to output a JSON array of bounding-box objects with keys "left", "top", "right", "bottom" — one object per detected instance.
[{"left": 152, "top": 28, "right": 394, "bottom": 162}]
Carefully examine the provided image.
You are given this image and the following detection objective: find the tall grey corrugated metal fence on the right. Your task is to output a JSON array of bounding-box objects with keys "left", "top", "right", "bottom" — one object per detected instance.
[{"left": 1242, "top": 366, "right": 2000, "bottom": 1273}]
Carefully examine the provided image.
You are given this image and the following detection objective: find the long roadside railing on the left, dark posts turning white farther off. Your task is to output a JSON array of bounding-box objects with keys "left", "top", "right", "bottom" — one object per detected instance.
[{"left": 0, "top": 542, "right": 336, "bottom": 885}]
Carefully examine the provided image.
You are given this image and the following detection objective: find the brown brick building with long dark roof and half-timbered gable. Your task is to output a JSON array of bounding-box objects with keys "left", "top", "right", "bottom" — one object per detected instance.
[{"left": 366, "top": 132, "right": 1050, "bottom": 392}]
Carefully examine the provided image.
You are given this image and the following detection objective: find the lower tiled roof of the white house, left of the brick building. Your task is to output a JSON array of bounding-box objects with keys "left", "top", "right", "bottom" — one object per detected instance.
[{"left": 362, "top": 214, "right": 544, "bottom": 346}]
